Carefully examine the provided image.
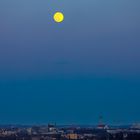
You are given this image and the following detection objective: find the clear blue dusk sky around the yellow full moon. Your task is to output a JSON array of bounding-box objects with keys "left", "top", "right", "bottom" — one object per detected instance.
[{"left": 0, "top": 0, "right": 140, "bottom": 124}]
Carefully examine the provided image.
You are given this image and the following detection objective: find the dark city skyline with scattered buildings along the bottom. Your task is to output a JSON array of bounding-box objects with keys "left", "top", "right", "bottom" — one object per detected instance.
[{"left": 0, "top": 125, "right": 140, "bottom": 140}]
